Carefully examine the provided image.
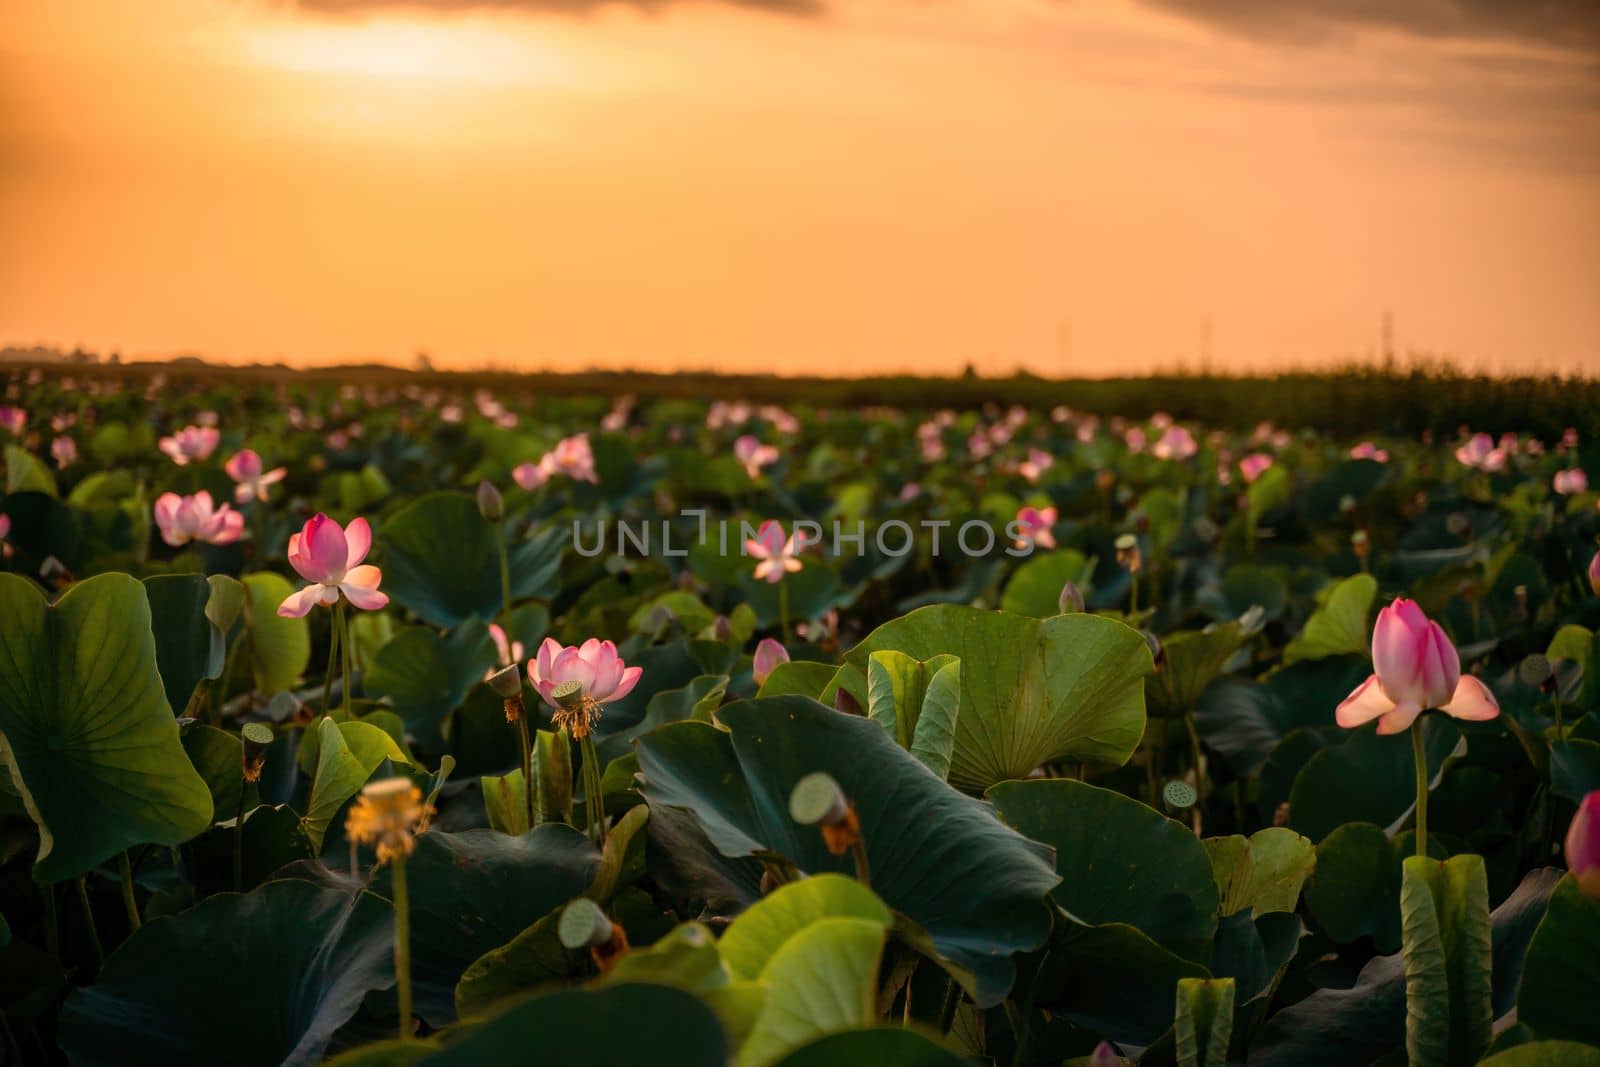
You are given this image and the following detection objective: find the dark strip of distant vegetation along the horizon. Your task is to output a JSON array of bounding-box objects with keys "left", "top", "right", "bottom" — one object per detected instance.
[{"left": 5, "top": 358, "right": 1600, "bottom": 440}]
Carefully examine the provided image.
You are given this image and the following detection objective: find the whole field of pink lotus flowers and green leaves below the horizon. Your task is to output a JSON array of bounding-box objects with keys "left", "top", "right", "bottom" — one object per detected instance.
[{"left": 0, "top": 368, "right": 1600, "bottom": 1067}]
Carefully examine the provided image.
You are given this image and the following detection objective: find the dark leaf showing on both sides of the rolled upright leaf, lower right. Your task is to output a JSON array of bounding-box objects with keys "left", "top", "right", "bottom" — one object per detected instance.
[{"left": 1250, "top": 869, "right": 1560, "bottom": 1067}]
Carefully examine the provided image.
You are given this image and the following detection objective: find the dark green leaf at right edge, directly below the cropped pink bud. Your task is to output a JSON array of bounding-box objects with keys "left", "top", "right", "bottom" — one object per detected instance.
[{"left": 1517, "top": 875, "right": 1600, "bottom": 1045}]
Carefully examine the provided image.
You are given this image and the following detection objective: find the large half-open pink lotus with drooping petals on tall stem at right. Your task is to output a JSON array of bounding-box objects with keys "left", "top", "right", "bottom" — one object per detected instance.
[{"left": 1334, "top": 597, "right": 1499, "bottom": 734}]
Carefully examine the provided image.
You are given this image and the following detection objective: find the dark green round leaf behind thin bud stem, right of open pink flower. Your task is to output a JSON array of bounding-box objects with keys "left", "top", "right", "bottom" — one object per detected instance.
[{"left": 378, "top": 493, "right": 566, "bottom": 627}]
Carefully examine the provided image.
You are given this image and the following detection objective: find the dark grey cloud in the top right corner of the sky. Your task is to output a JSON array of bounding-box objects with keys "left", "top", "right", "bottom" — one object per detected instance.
[{"left": 1144, "top": 0, "right": 1600, "bottom": 53}]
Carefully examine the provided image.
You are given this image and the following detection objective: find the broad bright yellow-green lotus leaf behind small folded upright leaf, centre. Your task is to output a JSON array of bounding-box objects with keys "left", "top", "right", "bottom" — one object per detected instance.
[{"left": 842, "top": 605, "right": 1152, "bottom": 792}]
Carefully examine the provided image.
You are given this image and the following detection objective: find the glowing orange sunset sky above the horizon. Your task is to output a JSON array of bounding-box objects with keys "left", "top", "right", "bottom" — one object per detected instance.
[{"left": 0, "top": 0, "right": 1600, "bottom": 373}]
